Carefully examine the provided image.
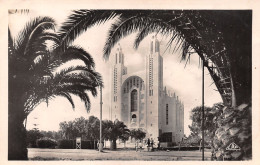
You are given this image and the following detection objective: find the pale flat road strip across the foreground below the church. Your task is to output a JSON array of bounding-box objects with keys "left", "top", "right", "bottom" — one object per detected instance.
[{"left": 28, "top": 148, "right": 210, "bottom": 161}]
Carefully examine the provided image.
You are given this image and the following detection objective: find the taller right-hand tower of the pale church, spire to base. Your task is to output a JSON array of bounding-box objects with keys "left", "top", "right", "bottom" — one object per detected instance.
[{"left": 146, "top": 36, "right": 163, "bottom": 140}]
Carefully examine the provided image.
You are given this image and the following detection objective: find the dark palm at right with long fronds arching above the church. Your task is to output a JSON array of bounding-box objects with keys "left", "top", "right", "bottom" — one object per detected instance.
[{"left": 59, "top": 10, "right": 252, "bottom": 107}]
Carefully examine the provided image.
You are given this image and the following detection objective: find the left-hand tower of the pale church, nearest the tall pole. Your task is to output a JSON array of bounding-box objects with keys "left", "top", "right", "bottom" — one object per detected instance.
[{"left": 111, "top": 44, "right": 127, "bottom": 121}]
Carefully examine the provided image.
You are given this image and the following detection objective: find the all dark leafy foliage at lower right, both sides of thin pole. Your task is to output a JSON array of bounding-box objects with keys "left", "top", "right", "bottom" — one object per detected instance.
[{"left": 188, "top": 103, "right": 252, "bottom": 160}]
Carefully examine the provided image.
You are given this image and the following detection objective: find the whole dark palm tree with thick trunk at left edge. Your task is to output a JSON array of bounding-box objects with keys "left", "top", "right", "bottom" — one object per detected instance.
[{"left": 8, "top": 17, "right": 102, "bottom": 160}]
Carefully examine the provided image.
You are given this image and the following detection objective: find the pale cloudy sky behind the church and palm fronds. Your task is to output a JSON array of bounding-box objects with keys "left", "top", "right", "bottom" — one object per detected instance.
[{"left": 9, "top": 10, "right": 221, "bottom": 135}]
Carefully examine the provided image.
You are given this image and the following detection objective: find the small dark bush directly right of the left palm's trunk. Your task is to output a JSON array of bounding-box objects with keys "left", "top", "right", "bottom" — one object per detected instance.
[{"left": 26, "top": 129, "right": 44, "bottom": 148}]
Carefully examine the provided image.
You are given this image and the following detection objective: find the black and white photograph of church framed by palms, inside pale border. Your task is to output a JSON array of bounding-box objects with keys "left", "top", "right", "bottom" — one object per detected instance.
[{"left": 1, "top": 2, "right": 259, "bottom": 163}]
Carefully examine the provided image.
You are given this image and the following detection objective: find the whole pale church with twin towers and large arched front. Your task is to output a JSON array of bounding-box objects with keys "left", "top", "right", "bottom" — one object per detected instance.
[{"left": 110, "top": 36, "right": 184, "bottom": 143}]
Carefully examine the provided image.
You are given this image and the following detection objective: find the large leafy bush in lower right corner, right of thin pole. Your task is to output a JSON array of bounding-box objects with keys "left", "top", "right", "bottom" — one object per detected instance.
[{"left": 214, "top": 104, "right": 252, "bottom": 160}]
